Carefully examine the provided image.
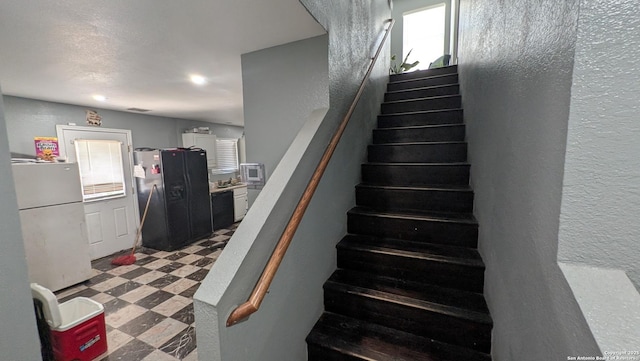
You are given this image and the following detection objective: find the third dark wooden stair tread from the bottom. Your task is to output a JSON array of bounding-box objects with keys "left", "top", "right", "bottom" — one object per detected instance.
[{"left": 337, "top": 234, "right": 484, "bottom": 268}]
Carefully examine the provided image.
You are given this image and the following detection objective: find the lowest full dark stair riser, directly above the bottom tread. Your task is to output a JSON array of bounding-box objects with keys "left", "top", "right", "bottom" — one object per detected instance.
[{"left": 325, "top": 287, "right": 491, "bottom": 352}]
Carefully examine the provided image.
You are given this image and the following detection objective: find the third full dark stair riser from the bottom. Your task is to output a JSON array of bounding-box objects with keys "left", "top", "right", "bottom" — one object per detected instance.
[{"left": 347, "top": 213, "right": 478, "bottom": 248}]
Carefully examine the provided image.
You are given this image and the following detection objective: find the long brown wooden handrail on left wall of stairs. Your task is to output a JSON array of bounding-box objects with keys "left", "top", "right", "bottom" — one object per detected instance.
[{"left": 227, "top": 19, "right": 395, "bottom": 327}]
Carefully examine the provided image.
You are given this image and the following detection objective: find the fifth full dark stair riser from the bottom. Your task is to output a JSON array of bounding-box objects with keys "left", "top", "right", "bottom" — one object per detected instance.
[{"left": 361, "top": 164, "right": 470, "bottom": 186}]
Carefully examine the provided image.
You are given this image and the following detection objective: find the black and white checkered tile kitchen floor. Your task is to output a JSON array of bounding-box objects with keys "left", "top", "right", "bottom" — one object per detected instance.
[{"left": 56, "top": 224, "right": 237, "bottom": 361}]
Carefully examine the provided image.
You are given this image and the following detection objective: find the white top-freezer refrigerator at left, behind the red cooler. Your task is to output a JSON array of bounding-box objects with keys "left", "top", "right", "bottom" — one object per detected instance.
[{"left": 12, "top": 163, "right": 92, "bottom": 291}]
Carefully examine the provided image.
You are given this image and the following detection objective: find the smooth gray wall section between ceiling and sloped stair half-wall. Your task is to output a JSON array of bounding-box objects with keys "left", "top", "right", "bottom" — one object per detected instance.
[{"left": 242, "top": 35, "right": 329, "bottom": 204}]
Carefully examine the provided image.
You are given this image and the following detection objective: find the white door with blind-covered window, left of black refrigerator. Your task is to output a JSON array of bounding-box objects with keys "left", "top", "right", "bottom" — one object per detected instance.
[{"left": 56, "top": 125, "right": 139, "bottom": 260}]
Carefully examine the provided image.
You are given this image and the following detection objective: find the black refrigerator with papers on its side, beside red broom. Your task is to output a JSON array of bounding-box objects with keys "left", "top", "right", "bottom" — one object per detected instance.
[{"left": 134, "top": 148, "right": 213, "bottom": 251}]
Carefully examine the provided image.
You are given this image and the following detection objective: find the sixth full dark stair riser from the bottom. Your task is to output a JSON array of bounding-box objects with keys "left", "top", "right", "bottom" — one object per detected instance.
[{"left": 368, "top": 143, "right": 467, "bottom": 163}]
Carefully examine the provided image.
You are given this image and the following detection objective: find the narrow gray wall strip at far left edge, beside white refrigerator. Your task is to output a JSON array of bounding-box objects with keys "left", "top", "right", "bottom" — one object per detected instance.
[{"left": 0, "top": 86, "right": 41, "bottom": 361}]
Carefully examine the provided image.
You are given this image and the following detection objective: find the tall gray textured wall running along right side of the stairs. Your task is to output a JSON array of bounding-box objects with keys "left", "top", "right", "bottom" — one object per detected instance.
[{"left": 459, "top": 0, "right": 599, "bottom": 361}]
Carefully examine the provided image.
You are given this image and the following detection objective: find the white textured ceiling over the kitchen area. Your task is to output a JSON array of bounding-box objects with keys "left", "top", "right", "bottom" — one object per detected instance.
[{"left": 0, "top": 0, "right": 324, "bottom": 125}]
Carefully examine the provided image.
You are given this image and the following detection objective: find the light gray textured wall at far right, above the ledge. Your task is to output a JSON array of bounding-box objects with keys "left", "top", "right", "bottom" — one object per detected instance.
[{"left": 558, "top": 0, "right": 640, "bottom": 287}]
